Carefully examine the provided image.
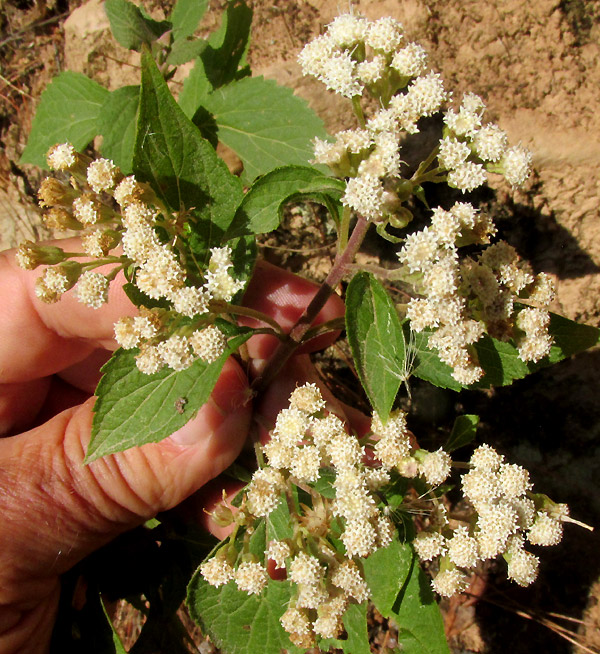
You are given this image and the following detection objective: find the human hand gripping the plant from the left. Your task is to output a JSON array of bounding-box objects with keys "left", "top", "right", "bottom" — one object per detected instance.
[{"left": 0, "top": 247, "right": 343, "bottom": 654}]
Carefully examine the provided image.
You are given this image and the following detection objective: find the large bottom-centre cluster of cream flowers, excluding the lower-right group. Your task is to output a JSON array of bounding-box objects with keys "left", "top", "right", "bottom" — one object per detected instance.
[{"left": 201, "top": 384, "right": 451, "bottom": 647}]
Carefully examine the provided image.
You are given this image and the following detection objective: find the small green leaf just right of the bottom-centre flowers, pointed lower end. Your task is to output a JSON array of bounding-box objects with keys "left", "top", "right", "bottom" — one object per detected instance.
[{"left": 363, "top": 532, "right": 413, "bottom": 618}]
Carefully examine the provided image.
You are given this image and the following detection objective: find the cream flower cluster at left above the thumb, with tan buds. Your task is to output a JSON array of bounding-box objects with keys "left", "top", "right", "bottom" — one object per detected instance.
[{"left": 16, "top": 143, "right": 244, "bottom": 374}]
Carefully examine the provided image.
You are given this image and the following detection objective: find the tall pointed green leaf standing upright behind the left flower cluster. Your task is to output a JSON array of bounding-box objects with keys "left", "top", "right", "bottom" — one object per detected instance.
[{"left": 133, "top": 51, "right": 242, "bottom": 247}]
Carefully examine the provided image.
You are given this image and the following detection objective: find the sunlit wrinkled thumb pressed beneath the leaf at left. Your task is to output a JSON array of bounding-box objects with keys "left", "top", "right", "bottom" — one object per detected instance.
[{"left": 0, "top": 359, "right": 251, "bottom": 584}]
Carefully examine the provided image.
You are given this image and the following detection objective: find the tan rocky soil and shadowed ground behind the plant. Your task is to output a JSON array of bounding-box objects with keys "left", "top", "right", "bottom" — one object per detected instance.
[{"left": 0, "top": 0, "right": 600, "bottom": 653}]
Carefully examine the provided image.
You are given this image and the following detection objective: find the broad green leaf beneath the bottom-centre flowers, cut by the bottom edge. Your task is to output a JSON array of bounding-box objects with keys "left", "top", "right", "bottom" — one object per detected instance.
[{"left": 187, "top": 572, "right": 304, "bottom": 654}]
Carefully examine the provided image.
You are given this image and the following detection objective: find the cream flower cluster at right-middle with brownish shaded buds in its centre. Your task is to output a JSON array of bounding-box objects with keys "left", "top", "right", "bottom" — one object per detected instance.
[{"left": 398, "top": 202, "right": 554, "bottom": 385}]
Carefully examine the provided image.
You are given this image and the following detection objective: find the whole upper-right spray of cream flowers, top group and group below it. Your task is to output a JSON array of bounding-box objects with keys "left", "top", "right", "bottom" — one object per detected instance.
[{"left": 300, "top": 14, "right": 554, "bottom": 385}]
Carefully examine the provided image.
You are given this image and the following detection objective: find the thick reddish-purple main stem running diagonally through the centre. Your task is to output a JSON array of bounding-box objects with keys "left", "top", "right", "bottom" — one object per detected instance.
[{"left": 251, "top": 216, "right": 369, "bottom": 394}]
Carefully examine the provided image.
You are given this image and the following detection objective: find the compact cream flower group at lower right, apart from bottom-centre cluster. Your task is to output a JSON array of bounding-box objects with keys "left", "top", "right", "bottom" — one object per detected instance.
[{"left": 413, "top": 445, "right": 568, "bottom": 597}]
